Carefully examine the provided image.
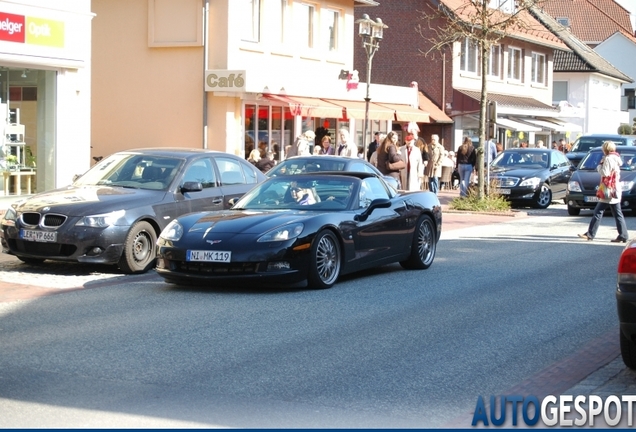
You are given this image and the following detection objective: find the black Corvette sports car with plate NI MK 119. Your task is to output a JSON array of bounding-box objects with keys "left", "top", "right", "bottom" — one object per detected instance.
[{"left": 156, "top": 172, "right": 442, "bottom": 289}]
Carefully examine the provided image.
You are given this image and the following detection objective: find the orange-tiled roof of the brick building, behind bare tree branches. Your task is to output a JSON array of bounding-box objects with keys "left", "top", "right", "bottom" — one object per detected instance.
[{"left": 439, "top": 0, "right": 568, "bottom": 51}]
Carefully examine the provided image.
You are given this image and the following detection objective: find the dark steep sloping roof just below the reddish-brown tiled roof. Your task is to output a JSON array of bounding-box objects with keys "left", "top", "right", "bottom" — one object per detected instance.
[{"left": 530, "top": 7, "right": 634, "bottom": 83}]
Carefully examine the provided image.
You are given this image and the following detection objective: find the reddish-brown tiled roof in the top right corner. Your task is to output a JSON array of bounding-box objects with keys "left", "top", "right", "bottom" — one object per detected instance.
[{"left": 542, "top": 0, "right": 636, "bottom": 45}]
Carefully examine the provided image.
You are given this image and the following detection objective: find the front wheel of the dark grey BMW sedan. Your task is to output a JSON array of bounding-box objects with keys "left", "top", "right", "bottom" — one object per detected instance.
[{"left": 119, "top": 222, "right": 157, "bottom": 273}]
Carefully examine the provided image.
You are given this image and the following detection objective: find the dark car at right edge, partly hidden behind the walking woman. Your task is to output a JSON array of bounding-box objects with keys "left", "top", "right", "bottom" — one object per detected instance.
[{"left": 565, "top": 146, "right": 636, "bottom": 216}]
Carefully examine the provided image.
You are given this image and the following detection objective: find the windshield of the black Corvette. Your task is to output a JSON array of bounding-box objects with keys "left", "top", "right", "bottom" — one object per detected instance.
[{"left": 234, "top": 176, "right": 360, "bottom": 210}]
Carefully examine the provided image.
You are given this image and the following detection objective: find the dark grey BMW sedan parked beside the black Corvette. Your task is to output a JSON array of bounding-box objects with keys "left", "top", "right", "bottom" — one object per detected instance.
[{"left": 0, "top": 148, "right": 265, "bottom": 273}]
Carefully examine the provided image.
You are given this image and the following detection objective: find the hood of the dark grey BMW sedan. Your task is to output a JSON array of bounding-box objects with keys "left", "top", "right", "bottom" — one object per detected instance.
[{"left": 16, "top": 186, "right": 166, "bottom": 216}]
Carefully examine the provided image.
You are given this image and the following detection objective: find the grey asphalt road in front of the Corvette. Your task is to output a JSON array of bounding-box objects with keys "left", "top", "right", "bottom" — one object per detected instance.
[{"left": 0, "top": 206, "right": 636, "bottom": 428}]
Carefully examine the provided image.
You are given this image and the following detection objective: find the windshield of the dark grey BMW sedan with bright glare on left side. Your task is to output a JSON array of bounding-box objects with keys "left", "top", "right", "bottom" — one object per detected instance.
[{"left": 73, "top": 153, "right": 183, "bottom": 190}]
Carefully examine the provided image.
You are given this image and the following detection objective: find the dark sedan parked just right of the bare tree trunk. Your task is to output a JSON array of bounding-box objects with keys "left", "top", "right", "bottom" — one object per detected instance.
[{"left": 490, "top": 148, "right": 575, "bottom": 209}]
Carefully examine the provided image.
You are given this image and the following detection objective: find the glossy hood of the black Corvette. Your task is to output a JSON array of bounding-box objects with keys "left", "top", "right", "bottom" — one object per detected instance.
[{"left": 184, "top": 210, "right": 317, "bottom": 234}]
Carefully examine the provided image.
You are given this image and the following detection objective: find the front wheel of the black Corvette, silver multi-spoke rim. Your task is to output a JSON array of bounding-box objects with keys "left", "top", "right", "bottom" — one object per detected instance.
[{"left": 307, "top": 230, "right": 341, "bottom": 289}]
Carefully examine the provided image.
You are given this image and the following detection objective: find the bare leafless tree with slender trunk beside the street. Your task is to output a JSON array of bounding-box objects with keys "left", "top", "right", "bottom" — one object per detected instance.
[{"left": 416, "top": 0, "right": 546, "bottom": 199}]
